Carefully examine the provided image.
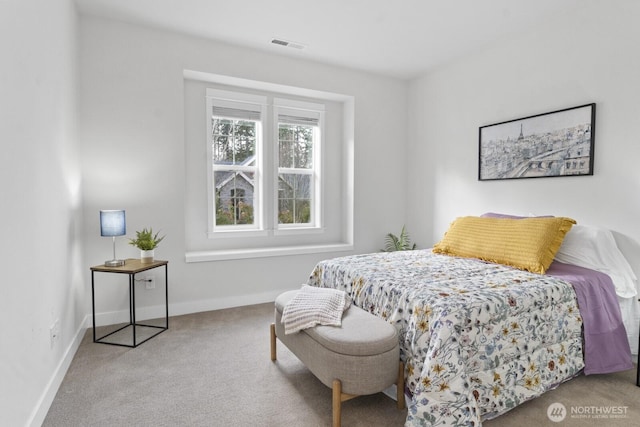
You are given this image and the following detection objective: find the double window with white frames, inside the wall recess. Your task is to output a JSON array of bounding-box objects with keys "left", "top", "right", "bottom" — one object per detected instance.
[{"left": 207, "top": 89, "right": 324, "bottom": 237}]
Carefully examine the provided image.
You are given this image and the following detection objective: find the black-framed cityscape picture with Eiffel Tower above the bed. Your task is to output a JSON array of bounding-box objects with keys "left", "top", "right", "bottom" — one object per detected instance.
[{"left": 478, "top": 103, "right": 596, "bottom": 181}]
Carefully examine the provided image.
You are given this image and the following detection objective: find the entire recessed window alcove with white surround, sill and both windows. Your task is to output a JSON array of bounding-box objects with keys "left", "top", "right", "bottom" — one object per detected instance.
[{"left": 184, "top": 70, "right": 355, "bottom": 263}]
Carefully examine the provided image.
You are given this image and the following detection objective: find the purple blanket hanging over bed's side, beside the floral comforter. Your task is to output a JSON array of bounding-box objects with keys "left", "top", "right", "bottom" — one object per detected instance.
[{"left": 547, "top": 261, "right": 633, "bottom": 375}]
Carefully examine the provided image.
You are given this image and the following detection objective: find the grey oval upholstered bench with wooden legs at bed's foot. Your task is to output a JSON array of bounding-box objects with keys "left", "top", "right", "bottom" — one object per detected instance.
[{"left": 271, "top": 291, "right": 405, "bottom": 427}]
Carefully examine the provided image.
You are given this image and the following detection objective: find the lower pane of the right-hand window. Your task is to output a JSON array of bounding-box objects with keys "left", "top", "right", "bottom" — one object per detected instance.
[{"left": 278, "top": 174, "right": 311, "bottom": 224}]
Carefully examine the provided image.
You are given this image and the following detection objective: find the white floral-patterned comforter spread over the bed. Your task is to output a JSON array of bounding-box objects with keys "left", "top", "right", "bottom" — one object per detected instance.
[{"left": 309, "top": 249, "right": 584, "bottom": 426}]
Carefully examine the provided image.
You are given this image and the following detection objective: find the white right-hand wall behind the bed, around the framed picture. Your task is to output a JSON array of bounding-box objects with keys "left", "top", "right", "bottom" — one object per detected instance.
[{"left": 407, "top": 0, "right": 640, "bottom": 350}]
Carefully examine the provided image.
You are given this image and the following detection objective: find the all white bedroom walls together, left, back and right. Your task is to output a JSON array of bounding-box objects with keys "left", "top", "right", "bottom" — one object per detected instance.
[{"left": 5, "top": 0, "right": 640, "bottom": 425}]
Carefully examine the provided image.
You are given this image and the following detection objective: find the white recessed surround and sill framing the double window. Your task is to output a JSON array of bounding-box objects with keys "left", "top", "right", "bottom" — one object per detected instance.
[{"left": 183, "top": 69, "right": 355, "bottom": 263}]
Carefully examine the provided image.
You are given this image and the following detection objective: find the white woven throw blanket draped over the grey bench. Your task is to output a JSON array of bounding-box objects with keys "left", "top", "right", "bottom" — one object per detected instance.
[{"left": 282, "top": 285, "right": 351, "bottom": 335}]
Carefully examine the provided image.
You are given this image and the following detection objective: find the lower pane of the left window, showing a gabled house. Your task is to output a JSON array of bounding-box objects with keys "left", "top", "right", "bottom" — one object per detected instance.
[{"left": 213, "top": 171, "right": 255, "bottom": 226}]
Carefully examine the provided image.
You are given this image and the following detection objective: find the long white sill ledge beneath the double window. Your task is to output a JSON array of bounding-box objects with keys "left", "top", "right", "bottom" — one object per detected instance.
[{"left": 185, "top": 243, "right": 354, "bottom": 263}]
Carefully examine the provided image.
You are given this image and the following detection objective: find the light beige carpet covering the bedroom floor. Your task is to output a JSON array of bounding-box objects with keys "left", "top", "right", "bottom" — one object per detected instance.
[{"left": 43, "top": 304, "right": 640, "bottom": 427}]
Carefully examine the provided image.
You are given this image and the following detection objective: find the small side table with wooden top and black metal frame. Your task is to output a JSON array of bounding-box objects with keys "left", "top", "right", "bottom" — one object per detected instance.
[{"left": 91, "top": 258, "right": 169, "bottom": 347}]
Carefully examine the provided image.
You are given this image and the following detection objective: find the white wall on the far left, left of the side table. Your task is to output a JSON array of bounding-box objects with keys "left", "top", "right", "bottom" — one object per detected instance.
[{"left": 0, "top": 0, "right": 88, "bottom": 426}]
